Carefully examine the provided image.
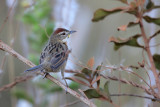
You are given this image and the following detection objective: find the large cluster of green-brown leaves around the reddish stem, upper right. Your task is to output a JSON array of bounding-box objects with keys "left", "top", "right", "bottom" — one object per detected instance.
[{"left": 92, "top": 0, "right": 160, "bottom": 70}]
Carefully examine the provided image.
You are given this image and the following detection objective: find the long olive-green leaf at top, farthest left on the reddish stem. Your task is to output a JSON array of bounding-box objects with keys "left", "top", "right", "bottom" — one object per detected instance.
[{"left": 92, "top": 7, "right": 124, "bottom": 22}]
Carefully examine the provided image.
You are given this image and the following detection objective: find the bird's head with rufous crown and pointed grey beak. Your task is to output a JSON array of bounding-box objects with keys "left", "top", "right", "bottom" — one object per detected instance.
[{"left": 51, "top": 28, "right": 76, "bottom": 41}]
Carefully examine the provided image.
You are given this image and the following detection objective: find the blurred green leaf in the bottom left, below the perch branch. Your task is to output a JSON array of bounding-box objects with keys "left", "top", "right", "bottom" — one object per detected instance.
[{"left": 12, "top": 88, "right": 34, "bottom": 104}]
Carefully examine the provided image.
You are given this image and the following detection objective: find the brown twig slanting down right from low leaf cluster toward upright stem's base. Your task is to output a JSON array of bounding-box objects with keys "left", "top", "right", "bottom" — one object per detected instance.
[{"left": 101, "top": 74, "right": 152, "bottom": 95}]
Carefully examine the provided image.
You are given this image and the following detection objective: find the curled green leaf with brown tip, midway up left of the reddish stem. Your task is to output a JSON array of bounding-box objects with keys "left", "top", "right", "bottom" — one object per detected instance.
[{"left": 109, "top": 34, "right": 144, "bottom": 50}]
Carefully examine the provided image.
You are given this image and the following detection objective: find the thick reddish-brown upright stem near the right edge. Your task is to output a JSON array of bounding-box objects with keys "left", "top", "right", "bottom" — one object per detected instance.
[{"left": 139, "top": 13, "right": 160, "bottom": 98}]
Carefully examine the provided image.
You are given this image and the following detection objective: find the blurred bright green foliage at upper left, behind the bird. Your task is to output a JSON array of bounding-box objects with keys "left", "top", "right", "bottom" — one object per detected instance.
[{"left": 22, "top": 0, "right": 54, "bottom": 61}]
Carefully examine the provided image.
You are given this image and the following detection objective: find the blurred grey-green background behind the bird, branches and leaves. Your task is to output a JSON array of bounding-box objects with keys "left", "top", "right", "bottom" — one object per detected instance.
[{"left": 0, "top": 0, "right": 160, "bottom": 107}]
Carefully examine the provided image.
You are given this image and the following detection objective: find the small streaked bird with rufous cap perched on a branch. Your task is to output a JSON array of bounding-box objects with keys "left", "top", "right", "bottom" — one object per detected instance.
[{"left": 24, "top": 28, "right": 76, "bottom": 87}]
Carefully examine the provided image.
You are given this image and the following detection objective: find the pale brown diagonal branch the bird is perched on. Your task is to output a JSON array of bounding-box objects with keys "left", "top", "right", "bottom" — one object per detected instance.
[{"left": 0, "top": 40, "right": 96, "bottom": 107}]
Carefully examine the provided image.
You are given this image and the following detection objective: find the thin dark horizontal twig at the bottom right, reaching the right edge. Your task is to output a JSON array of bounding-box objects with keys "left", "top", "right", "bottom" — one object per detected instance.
[{"left": 110, "top": 94, "right": 160, "bottom": 101}]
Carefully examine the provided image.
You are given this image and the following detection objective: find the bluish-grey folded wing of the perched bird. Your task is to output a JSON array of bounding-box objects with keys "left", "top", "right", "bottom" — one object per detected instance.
[{"left": 50, "top": 52, "right": 68, "bottom": 70}]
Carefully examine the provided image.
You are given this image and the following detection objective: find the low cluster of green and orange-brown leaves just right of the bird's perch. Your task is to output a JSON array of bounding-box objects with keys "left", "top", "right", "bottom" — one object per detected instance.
[{"left": 66, "top": 57, "right": 112, "bottom": 102}]
